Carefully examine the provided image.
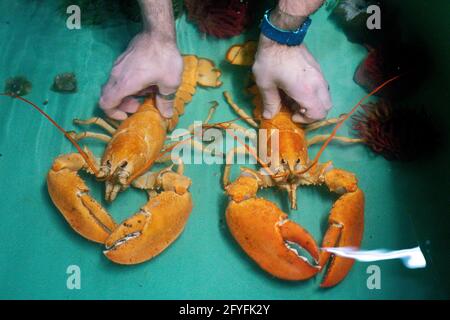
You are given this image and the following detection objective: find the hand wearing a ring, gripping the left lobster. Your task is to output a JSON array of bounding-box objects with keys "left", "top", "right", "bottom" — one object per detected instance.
[{"left": 99, "top": 31, "right": 183, "bottom": 120}]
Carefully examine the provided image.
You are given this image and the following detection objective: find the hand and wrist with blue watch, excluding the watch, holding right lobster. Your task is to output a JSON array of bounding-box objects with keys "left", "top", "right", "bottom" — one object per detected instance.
[{"left": 253, "top": 0, "right": 331, "bottom": 123}]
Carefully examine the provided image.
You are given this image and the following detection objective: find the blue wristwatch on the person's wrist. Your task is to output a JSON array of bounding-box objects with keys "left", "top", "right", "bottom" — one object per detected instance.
[{"left": 261, "top": 10, "right": 312, "bottom": 46}]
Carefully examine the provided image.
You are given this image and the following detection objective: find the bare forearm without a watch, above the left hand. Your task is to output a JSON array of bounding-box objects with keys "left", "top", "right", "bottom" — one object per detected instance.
[{"left": 139, "top": 0, "right": 175, "bottom": 41}]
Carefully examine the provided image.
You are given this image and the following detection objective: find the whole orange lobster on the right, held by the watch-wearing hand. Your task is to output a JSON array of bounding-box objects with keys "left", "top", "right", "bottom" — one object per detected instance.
[{"left": 223, "top": 43, "right": 400, "bottom": 287}]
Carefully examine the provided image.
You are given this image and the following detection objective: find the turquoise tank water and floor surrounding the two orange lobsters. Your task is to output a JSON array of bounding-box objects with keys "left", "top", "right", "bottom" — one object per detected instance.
[{"left": 0, "top": 0, "right": 449, "bottom": 299}]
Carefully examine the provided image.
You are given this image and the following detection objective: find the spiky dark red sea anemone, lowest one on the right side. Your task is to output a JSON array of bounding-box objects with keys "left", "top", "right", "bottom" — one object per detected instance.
[{"left": 352, "top": 100, "right": 440, "bottom": 161}]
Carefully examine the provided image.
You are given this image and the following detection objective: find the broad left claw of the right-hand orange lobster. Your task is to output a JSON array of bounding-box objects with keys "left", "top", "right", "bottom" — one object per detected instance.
[{"left": 226, "top": 198, "right": 320, "bottom": 280}]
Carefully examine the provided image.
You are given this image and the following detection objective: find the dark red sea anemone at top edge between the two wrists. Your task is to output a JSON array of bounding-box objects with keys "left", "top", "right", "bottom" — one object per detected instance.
[{"left": 184, "top": 0, "right": 258, "bottom": 38}]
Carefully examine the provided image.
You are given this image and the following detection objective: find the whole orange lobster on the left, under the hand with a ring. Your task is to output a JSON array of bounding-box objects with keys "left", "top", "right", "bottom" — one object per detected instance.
[{"left": 3, "top": 55, "right": 221, "bottom": 264}]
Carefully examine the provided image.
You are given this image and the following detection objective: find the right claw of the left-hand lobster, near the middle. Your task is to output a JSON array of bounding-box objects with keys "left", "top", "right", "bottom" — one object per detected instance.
[{"left": 104, "top": 191, "right": 192, "bottom": 264}]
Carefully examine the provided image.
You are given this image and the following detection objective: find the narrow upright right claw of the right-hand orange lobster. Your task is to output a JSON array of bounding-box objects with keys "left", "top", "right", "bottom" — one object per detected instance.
[{"left": 319, "top": 169, "right": 364, "bottom": 288}]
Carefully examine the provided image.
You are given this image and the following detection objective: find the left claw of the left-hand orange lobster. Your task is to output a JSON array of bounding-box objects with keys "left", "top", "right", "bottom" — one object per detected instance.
[{"left": 47, "top": 153, "right": 117, "bottom": 243}]
